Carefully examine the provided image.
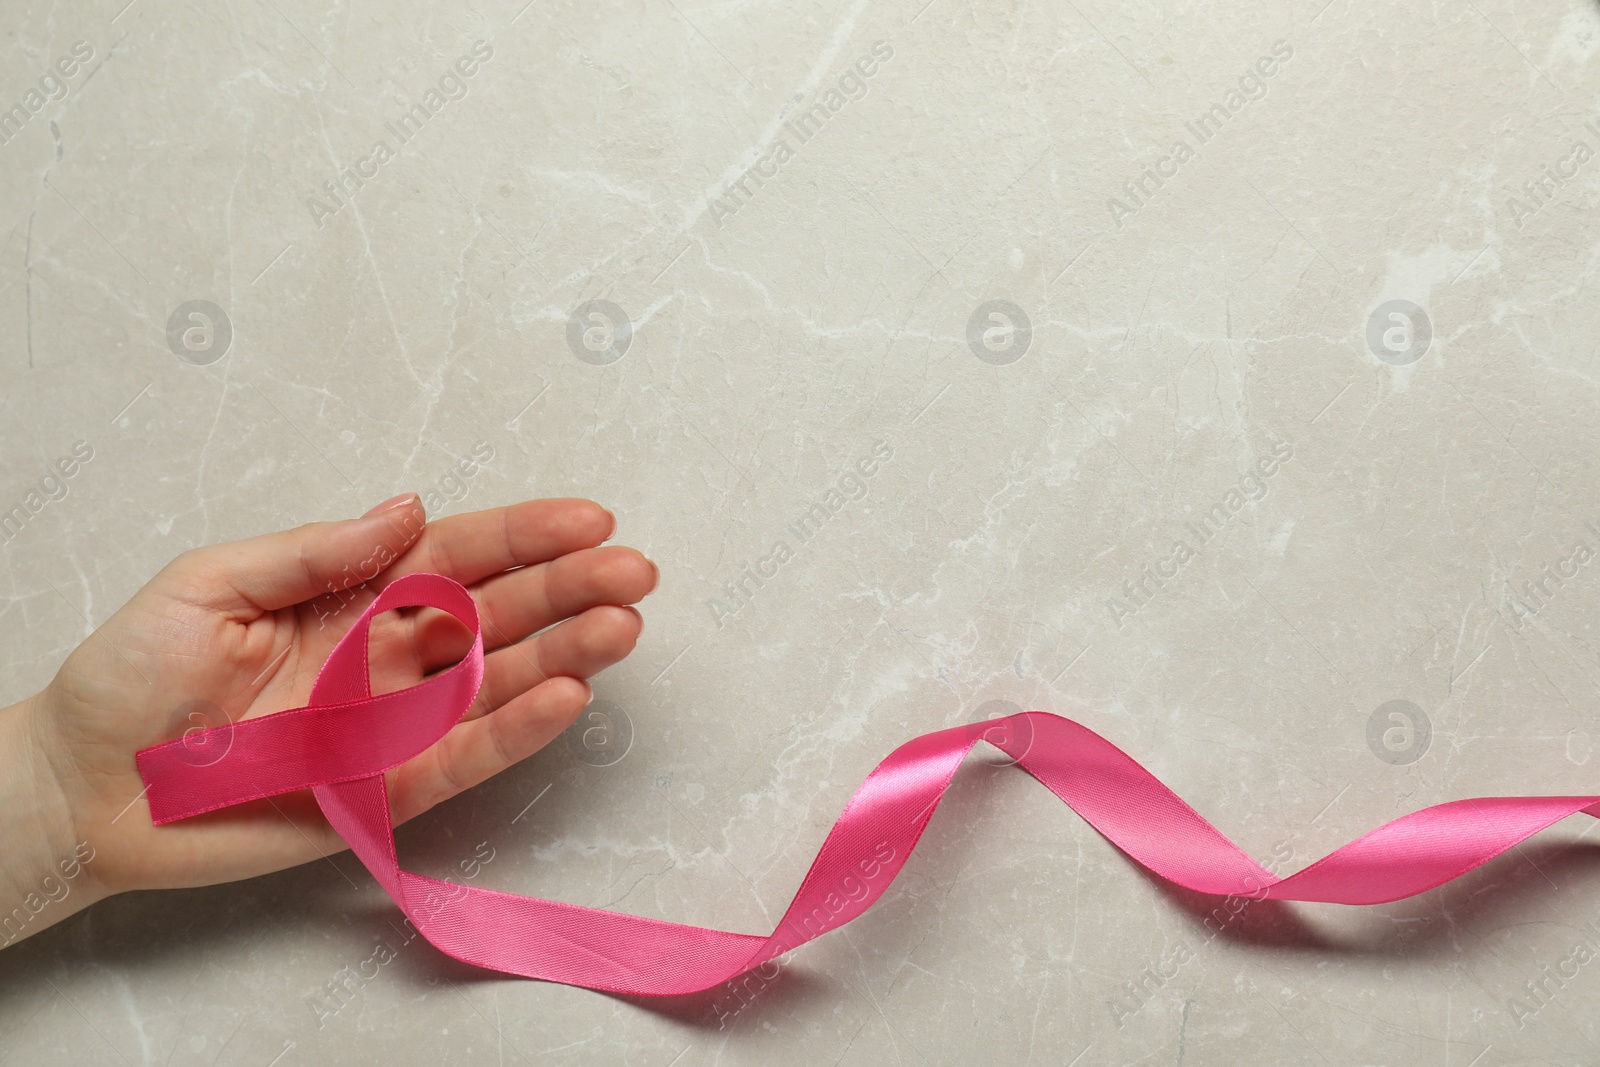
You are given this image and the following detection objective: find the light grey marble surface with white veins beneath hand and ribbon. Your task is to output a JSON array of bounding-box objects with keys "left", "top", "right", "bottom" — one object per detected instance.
[{"left": 0, "top": 0, "right": 1600, "bottom": 1067}]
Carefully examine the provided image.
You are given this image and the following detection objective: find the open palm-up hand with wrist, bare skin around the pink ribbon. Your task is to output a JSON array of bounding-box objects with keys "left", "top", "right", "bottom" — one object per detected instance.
[{"left": 0, "top": 493, "right": 659, "bottom": 944}]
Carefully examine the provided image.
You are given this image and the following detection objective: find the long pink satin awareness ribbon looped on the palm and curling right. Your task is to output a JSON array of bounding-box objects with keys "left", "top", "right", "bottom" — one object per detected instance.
[{"left": 136, "top": 574, "right": 1600, "bottom": 995}]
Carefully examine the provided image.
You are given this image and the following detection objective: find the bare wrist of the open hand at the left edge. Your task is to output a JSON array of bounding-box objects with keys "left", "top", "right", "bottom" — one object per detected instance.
[{"left": 0, "top": 696, "right": 109, "bottom": 949}]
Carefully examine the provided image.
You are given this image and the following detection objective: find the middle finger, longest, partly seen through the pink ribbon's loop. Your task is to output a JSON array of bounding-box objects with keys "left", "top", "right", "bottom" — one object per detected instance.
[{"left": 414, "top": 545, "right": 661, "bottom": 662}]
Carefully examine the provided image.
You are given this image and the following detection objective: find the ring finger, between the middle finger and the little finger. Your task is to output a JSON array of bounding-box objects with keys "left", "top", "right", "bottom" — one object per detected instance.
[{"left": 462, "top": 605, "right": 645, "bottom": 718}]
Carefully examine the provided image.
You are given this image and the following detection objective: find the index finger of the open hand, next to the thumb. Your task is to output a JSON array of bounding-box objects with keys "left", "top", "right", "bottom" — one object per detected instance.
[{"left": 382, "top": 499, "right": 616, "bottom": 585}]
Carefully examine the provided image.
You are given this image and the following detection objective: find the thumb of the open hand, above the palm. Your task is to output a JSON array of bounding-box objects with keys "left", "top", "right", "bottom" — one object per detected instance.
[{"left": 165, "top": 493, "right": 427, "bottom": 616}]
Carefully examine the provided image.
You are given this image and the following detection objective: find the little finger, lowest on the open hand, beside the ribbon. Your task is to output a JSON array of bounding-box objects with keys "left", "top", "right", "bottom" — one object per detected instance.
[{"left": 389, "top": 678, "right": 594, "bottom": 824}]
